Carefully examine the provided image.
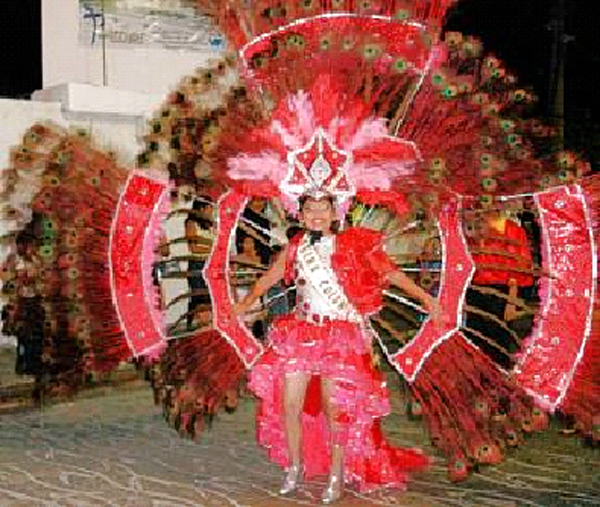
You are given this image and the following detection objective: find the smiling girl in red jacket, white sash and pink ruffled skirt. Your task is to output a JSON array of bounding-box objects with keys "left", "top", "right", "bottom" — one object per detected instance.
[{"left": 236, "top": 192, "right": 439, "bottom": 504}]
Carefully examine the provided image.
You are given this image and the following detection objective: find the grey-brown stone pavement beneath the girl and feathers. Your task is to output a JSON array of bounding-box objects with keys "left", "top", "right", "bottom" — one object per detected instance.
[{"left": 0, "top": 387, "right": 600, "bottom": 507}]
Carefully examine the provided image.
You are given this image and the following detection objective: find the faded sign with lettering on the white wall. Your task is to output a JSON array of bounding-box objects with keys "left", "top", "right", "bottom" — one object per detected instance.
[{"left": 79, "top": 0, "right": 225, "bottom": 52}]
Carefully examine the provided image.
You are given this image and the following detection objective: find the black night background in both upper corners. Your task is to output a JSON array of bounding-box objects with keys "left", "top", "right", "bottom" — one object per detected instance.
[{"left": 0, "top": 0, "right": 600, "bottom": 164}]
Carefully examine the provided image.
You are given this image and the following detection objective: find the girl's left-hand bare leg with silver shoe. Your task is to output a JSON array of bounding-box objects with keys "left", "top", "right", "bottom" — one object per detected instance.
[{"left": 280, "top": 372, "right": 310, "bottom": 495}]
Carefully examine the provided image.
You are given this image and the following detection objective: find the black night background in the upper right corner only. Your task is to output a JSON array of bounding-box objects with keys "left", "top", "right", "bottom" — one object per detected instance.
[{"left": 446, "top": 0, "right": 600, "bottom": 169}]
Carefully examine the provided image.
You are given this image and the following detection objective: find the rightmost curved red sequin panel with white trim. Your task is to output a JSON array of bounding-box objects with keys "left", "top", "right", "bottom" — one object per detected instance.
[{"left": 515, "top": 186, "right": 596, "bottom": 410}]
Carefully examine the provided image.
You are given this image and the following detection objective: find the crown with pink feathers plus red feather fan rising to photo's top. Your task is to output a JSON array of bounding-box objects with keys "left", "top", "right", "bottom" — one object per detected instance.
[{"left": 193, "top": 0, "right": 460, "bottom": 213}]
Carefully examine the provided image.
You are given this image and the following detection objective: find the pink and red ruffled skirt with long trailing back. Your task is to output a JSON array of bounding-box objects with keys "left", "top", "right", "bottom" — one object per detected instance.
[{"left": 250, "top": 315, "right": 429, "bottom": 491}]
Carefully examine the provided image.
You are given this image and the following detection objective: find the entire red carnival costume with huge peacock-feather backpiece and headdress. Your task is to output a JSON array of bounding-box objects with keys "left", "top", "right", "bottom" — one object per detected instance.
[{"left": 5, "top": 0, "right": 600, "bottom": 488}]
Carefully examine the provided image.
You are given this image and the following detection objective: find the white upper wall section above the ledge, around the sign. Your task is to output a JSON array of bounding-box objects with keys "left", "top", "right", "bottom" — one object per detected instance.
[{"left": 42, "top": 0, "right": 220, "bottom": 95}]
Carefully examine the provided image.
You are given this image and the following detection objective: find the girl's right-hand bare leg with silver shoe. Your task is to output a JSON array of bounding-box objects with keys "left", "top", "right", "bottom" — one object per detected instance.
[{"left": 321, "top": 378, "right": 344, "bottom": 504}]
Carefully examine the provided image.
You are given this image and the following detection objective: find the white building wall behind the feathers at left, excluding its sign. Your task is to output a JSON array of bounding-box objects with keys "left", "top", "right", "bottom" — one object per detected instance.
[{"left": 0, "top": 0, "right": 225, "bottom": 344}]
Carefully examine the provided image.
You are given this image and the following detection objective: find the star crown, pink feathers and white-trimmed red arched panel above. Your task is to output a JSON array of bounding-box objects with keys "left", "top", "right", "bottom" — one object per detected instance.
[{"left": 228, "top": 13, "right": 454, "bottom": 213}]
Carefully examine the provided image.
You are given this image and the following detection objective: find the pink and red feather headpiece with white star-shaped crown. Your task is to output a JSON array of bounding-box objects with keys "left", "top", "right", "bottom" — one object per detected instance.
[{"left": 227, "top": 75, "right": 419, "bottom": 213}]
